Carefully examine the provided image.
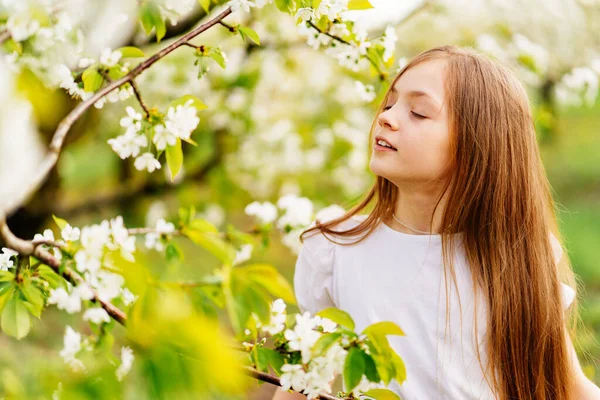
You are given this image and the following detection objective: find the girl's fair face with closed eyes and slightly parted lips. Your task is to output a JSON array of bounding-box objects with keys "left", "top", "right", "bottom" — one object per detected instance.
[{"left": 369, "top": 59, "right": 450, "bottom": 186}]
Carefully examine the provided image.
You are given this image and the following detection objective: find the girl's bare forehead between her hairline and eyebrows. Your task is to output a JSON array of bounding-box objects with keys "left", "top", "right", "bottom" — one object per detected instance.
[{"left": 390, "top": 60, "right": 446, "bottom": 105}]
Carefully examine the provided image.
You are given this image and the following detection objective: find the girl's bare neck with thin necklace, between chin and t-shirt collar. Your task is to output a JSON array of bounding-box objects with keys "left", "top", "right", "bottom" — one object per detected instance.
[{"left": 387, "top": 187, "right": 447, "bottom": 235}]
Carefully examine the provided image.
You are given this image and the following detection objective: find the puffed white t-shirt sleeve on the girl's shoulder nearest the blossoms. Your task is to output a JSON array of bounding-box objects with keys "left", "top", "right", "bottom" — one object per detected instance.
[{"left": 294, "top": 232, "right": 335, "bottom": 314}]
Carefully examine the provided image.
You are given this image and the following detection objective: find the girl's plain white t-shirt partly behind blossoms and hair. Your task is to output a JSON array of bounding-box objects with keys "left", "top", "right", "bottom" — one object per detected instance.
[{"left": 294, "top": 217, "right": 575, "bottom": 400}]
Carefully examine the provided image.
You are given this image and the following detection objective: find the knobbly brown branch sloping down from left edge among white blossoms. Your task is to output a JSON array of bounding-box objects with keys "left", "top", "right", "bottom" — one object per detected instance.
[{"left": 0, "top": 211, "right": 127, "bottom": 325}]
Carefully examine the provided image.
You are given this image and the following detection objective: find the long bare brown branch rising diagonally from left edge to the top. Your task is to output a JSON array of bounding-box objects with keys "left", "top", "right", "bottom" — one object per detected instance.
[{"left": 0, "top": 7, "right": 231, "bottom": 219}]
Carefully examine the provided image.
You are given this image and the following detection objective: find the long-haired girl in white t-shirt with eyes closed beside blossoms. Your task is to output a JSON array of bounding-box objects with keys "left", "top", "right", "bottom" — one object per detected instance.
[{"left": 274, "top": 46, "right": 600, "bottom": 400}]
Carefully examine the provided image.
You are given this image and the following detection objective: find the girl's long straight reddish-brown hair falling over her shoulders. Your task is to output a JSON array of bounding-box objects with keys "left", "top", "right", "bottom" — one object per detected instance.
[{"left": 301, "top": 46, "right": 577, "bottom": 400}]
